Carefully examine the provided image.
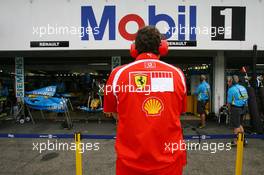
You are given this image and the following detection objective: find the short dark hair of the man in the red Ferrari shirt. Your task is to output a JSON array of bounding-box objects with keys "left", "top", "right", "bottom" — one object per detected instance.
[{"left": 135, "top": 26, "right": 161, "bottom": 54}]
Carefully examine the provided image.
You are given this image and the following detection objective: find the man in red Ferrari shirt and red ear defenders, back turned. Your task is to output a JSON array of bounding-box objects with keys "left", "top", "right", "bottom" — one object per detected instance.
[{"left": 104, "top": 26, "right": 186, "bottom": 175}]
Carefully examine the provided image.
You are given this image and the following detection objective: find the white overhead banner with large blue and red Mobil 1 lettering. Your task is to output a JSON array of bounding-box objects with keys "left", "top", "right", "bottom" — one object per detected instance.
[{"left": 0, "top": 0, "right": 264, "bottom": 50}]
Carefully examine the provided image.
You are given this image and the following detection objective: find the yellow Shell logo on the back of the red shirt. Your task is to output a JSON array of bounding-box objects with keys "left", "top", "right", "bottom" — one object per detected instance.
[{"left": 142, "top": 97, "right": 164, "bottom": 116}]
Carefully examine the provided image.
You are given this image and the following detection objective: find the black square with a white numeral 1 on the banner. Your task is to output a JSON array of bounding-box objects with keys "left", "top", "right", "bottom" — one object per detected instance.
[{"left": 212, "top": 6, "right": 246, "bottom": 41}]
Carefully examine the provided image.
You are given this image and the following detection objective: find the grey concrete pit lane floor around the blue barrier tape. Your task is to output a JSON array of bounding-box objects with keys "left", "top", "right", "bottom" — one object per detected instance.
[{"left": 0, "top": 118, "right": 264, "bottom": 175}]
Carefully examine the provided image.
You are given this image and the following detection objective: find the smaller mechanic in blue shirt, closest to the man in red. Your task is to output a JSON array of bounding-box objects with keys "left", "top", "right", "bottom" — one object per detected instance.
[{"left": 194, "top": 75, "right": 210, "bottom": 129}]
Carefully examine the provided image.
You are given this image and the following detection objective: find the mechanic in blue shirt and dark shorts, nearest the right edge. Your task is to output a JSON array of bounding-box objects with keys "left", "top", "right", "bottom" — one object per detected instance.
[{"left": 227, "top": 75, "right": 248, "bottom": 146}]
